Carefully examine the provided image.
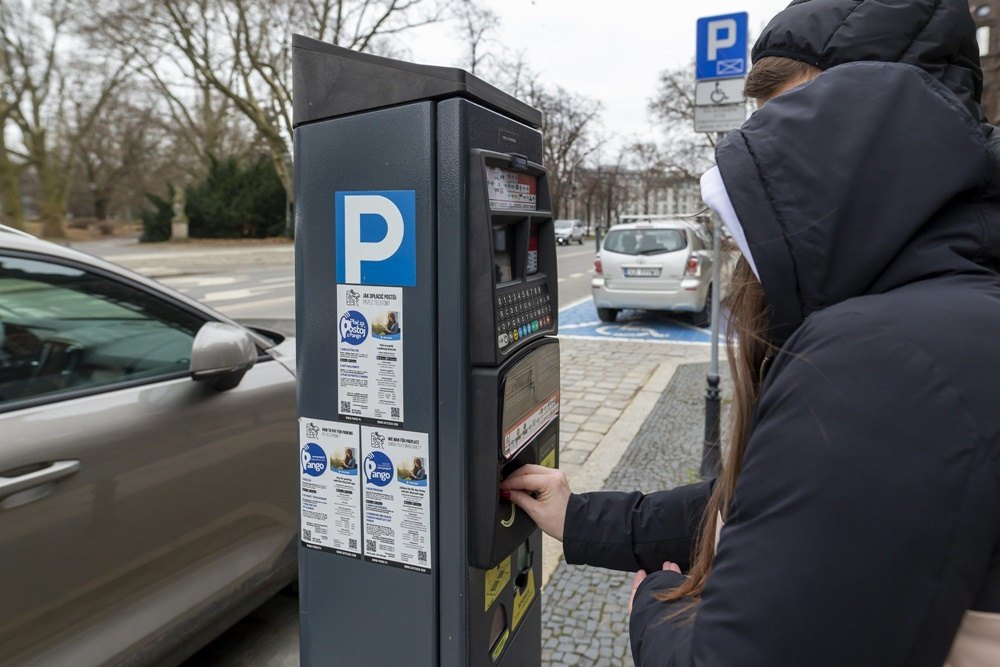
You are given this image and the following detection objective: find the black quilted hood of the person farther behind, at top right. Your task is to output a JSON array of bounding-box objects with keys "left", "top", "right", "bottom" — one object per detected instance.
[{"left": 751, "top": 0, "right": 983, "bottom": 118}]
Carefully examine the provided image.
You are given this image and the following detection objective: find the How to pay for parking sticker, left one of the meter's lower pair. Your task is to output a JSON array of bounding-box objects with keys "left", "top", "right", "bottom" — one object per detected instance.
[{"left": 299, "top": 417, "right": 361, "bottom": 558}]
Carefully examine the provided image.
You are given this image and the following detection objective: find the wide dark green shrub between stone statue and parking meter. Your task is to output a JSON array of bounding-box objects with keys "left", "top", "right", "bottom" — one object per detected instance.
[{"left": 185, "top": 157, "right": 285, "bottom": 238}]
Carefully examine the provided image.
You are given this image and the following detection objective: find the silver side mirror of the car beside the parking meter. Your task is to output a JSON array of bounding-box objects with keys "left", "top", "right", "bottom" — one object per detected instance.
[{"left": 191, "top": 322, "right": 257, "bottom": 391}]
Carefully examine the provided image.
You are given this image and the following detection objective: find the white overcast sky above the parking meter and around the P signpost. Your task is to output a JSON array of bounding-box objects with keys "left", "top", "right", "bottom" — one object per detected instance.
[{"left": 398, "top": 0, "right": 788, "bottom": 147}]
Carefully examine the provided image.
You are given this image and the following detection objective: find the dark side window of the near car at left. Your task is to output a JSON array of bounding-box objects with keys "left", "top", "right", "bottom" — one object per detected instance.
[{"left": 0, "top": 255, "right": 202, "bottom": 409}]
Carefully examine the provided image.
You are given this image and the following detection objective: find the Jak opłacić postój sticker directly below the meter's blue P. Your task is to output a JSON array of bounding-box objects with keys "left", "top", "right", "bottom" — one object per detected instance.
[{"left": 337, "top": 285, "right": 404, "bottom": 425}]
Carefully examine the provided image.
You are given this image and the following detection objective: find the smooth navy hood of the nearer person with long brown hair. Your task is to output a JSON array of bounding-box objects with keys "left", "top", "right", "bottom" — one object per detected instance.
[{"left": 716, "top": 62, "right": 1000, "bottom": 345}]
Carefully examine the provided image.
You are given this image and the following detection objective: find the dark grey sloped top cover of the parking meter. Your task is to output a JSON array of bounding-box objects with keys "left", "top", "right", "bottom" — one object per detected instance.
[{"left": 292, "top": 35, "right": 542, "bottom": 128}]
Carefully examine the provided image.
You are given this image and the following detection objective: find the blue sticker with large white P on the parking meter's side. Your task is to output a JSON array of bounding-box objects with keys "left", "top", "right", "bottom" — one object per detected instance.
[{"left": 335, "top": 190, "right": 417, "bottom": 287}]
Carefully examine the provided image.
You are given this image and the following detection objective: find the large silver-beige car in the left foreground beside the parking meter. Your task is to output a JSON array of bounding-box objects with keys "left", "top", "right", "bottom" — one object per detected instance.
[{"left": 0, "top": 228, "right": 298, "bottom": 666}]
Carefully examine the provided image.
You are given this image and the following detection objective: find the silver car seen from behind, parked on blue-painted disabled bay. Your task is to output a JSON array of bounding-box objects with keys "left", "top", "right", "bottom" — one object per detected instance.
[{"left": 591, "top": 220, "right": 712, "bottom": 326}]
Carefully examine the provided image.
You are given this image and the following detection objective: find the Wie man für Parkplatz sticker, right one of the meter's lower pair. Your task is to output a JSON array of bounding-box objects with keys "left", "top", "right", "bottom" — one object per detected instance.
[{"left": 361, "top": 426, "right": 432, "bottom": 573}]
